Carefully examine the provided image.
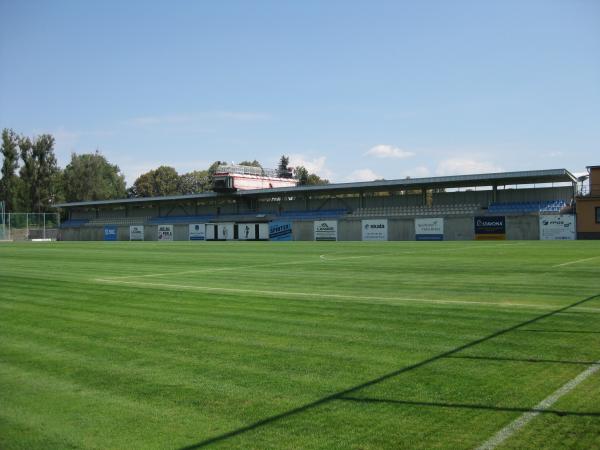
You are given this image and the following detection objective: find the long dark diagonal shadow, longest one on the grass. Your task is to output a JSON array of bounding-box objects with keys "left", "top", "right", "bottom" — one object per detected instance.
[{"left": 180, "top": 294, "right": 600, "bottom": 450}]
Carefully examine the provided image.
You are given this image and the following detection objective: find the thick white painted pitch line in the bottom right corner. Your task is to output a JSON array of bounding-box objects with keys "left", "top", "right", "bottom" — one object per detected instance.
[{"left": 476, "top": 361, "right": 600, "bottom": 450}]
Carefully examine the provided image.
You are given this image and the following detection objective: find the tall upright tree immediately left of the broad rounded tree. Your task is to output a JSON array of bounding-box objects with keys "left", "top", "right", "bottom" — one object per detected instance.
[{"left": 19, "top": 134, "right": 60, "bottom": 212}]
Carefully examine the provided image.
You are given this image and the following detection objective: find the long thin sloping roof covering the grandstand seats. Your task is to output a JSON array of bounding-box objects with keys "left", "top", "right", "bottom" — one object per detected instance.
[{"left": 54, "top": 169, "right": 577, "bottom": 208}]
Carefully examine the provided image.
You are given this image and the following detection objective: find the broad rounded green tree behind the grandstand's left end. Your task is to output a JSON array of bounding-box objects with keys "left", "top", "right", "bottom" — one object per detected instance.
[{"left": 63, "top": 151, "right": 127, "bottom": 202}]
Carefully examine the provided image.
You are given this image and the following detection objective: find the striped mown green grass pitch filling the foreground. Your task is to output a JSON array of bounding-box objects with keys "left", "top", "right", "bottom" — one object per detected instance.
[{"left": 0, "top": 241, "right": 600, "bottom": 450}]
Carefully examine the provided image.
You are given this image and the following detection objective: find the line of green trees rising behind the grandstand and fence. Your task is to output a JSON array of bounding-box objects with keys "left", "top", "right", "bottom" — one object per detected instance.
[{"left": 0, "top": 129, "right": 329, "bottom": 212}]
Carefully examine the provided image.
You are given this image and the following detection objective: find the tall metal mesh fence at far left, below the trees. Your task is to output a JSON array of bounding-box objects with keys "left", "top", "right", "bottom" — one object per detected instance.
[{"left": 0, "top": 212, "right": 60, "bottom": 241}]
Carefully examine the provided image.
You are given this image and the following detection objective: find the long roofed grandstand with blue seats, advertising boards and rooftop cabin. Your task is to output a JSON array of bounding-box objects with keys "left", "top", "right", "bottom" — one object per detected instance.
[{"left": 50, "top": 166, "right": 595, "bottom": 241}]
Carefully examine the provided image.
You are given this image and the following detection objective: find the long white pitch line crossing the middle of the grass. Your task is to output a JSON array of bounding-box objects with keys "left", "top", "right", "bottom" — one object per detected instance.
[{"left": 93, "top": 278, "right": 556, "bottom": 310}]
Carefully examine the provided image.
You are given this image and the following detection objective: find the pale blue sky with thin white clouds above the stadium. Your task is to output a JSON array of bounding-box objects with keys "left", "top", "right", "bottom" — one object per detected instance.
[{"left": 0, "top": 0, "right": 600, "bottom": 183}]
